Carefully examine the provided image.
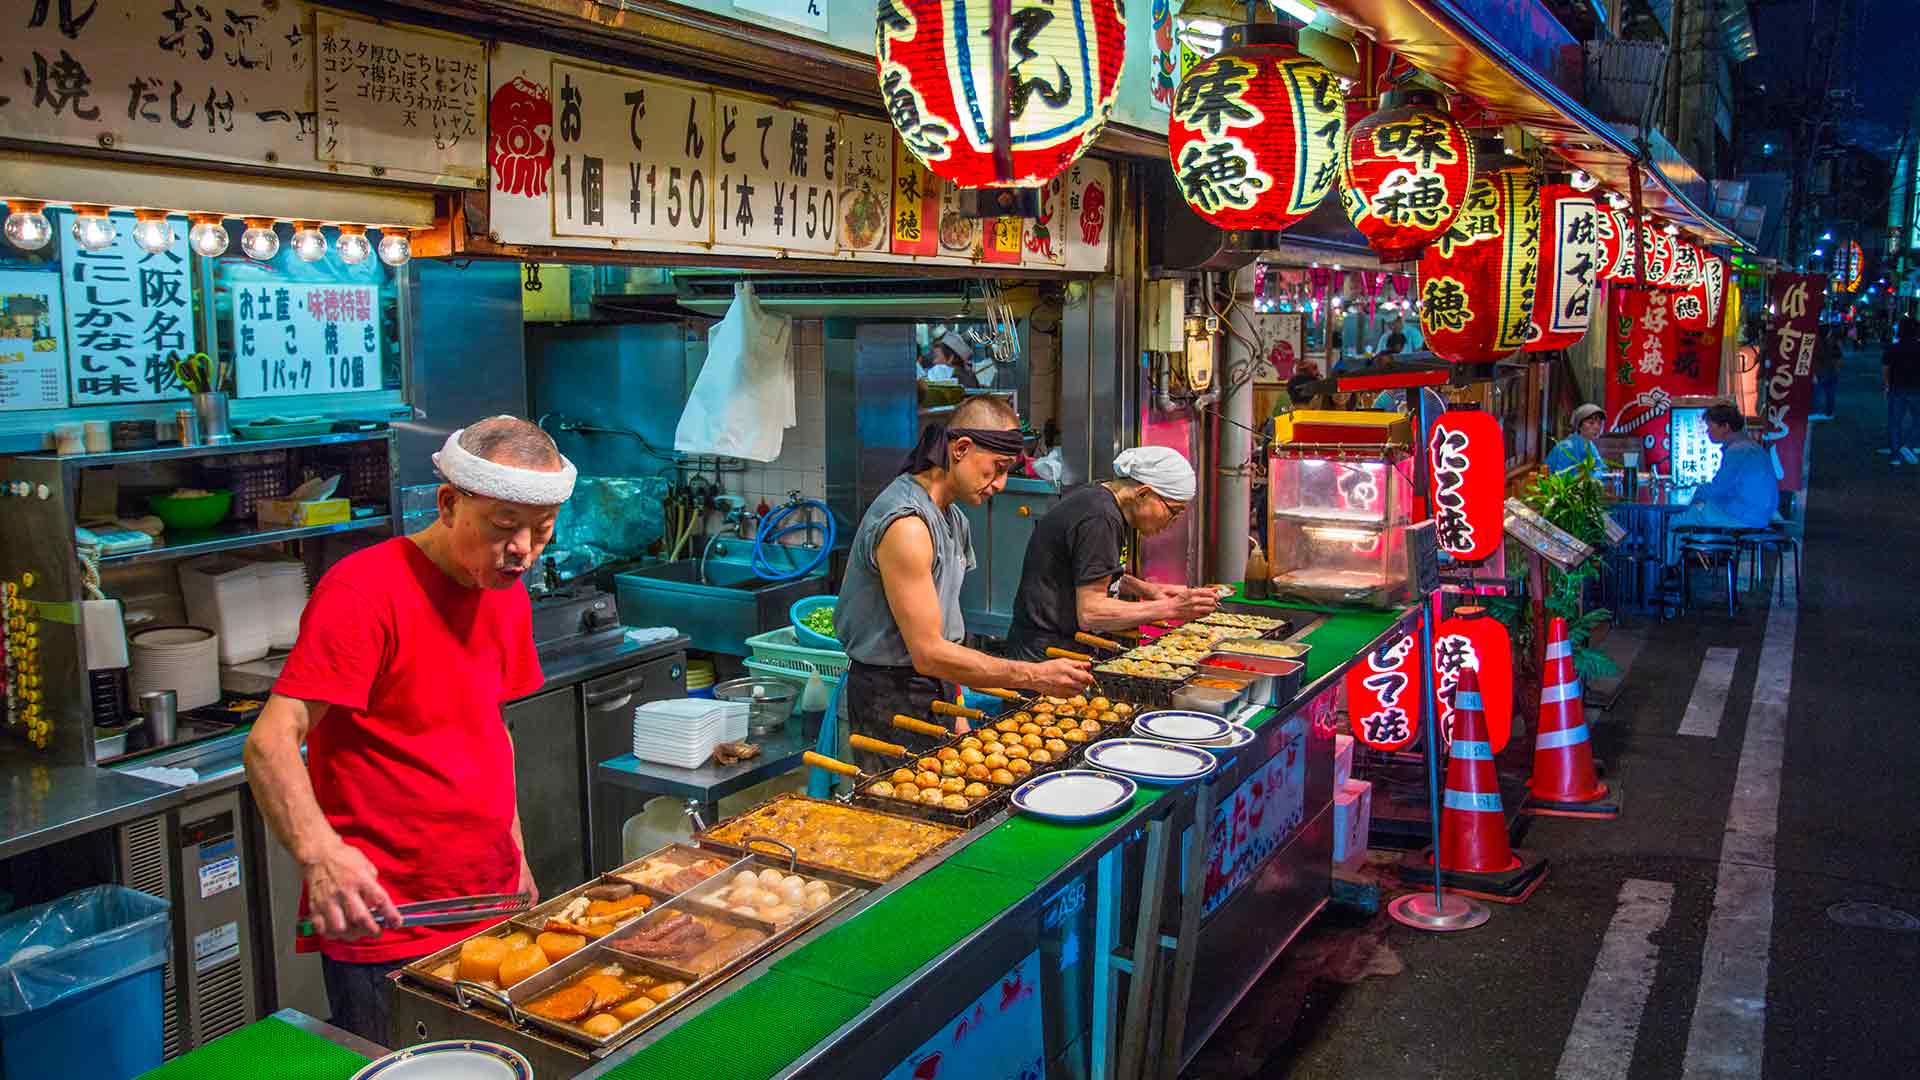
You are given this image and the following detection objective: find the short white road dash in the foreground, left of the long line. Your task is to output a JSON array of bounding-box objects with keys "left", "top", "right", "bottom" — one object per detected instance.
[{"left": 1553, "top": 878, "right": 1674, "bottom": 1080}]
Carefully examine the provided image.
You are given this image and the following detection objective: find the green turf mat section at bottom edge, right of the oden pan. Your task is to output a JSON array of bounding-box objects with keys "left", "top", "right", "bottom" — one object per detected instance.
[{"left": 607, "top": 970, "right": 872, "bottom": 1080}]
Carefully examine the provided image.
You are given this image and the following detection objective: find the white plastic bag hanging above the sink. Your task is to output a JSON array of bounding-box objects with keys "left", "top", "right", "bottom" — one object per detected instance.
[{"left": 674, "top": 284, "right": 799, "bottom": 461}]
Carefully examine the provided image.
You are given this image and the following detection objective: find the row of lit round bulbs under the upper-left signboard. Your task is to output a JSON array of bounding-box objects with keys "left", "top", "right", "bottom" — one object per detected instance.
[{"left": 0, "top": 200, "right": 413, "bottom": 267}]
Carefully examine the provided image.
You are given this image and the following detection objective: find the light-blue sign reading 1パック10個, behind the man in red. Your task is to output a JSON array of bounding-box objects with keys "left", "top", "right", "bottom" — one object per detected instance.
[{"left": 230, "top": 282, "right": 380, "bottom": 398}]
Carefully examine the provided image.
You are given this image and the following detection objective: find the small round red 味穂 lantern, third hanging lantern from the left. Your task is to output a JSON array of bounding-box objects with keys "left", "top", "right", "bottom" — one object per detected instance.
[{"left": 1340, "top": 88, "right": 1473, "bottom": 263}]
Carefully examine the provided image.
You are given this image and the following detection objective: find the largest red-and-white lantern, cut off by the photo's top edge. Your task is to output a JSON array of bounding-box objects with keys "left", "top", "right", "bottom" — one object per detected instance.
[{"left": 874, "top": 0, "right": 1127, "bottom": 188}]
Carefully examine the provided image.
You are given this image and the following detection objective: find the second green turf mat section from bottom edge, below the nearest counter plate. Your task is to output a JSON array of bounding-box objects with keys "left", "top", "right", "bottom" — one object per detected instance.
[{"left": 774, "top": 857, "right": 1044, "bottom": 997}]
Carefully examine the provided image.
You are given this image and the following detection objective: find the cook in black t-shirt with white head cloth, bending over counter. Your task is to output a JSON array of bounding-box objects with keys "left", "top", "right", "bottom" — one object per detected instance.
[{"left": 1008, "top": 446, "right": 1219, "bottom": 659}]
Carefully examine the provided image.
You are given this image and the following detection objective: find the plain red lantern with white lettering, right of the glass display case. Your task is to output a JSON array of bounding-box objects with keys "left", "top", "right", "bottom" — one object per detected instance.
[{"left": 1427, "top": 405, "right": 1507, "bottom": 563}]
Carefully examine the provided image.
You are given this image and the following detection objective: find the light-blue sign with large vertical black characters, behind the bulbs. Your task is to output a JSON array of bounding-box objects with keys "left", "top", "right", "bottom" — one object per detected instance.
[{"left": 54, "top": 215, "right": 194, "bottom": 405}]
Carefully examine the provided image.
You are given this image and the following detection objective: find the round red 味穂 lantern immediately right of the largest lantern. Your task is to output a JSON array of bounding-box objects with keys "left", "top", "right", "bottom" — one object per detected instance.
[{"left": 1167, "top": 23, "right": 1346, "bottom": 231}]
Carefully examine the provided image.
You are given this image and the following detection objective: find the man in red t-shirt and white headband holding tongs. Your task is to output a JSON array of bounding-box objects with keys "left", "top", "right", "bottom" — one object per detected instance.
[{"left": 246, "top": 409, "right": 574, "bottom": 1045}]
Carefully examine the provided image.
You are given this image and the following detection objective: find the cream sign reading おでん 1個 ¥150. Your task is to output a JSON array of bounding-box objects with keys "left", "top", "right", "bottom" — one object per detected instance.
[{"left": 551, "top": 63, "right": 714, "bottom": 248}]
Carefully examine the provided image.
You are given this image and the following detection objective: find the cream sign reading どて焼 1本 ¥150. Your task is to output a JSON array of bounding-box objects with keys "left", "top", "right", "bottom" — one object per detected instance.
[{"left": 714, "top": 94, "right": 845, "bottom": 256}]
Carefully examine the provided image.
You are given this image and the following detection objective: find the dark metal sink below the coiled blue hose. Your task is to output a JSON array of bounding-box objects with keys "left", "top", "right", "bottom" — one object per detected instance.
[{"left": 612, "top": 540, "right": 828, "bottom": 655}]
